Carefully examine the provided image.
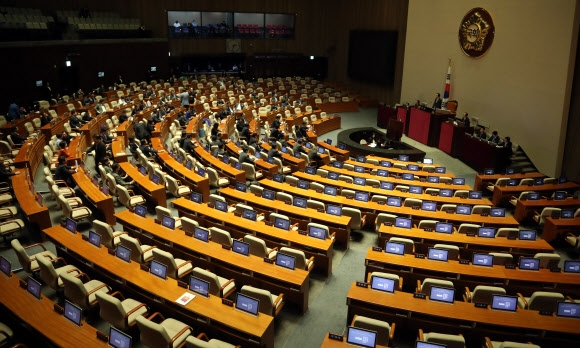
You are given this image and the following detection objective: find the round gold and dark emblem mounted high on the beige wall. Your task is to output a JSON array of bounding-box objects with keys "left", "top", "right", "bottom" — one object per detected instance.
[{"left": 459, "top": 7, "right": 495, "bottom": 58}]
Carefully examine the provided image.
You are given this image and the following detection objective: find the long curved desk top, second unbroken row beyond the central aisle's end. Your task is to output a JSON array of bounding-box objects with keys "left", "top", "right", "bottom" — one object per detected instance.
[{"left": 292, "top": 172, "right": 491, "bottom": 205}]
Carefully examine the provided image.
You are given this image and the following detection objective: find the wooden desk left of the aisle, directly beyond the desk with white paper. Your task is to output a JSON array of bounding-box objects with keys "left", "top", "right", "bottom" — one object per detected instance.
[{"left": 115, "top": 210, "right": 310, "bottom": 311}]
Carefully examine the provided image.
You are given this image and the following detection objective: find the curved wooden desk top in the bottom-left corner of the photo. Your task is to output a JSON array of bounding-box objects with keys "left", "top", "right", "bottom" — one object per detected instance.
[{"left": 0, "top": 274, "right": 108, "bottom": 347}]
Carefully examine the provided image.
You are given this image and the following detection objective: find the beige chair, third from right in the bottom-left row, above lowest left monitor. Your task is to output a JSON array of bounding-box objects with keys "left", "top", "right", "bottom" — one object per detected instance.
[{"left": 95, "top": 291, "right": 149, "bottom": 331}]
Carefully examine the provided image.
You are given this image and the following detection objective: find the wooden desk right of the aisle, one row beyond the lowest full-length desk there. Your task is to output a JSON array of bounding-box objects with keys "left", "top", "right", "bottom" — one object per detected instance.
[{"left": 365, "top": 249, "right": 580, "bottom": 298}]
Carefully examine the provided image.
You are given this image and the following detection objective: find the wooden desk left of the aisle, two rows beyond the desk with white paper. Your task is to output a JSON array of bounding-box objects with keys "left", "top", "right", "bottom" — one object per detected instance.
[{"left": 173, "top": 198, "right": 334, "bottom": 282}]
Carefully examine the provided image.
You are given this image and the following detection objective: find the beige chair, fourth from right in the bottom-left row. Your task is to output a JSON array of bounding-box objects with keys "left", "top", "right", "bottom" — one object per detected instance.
[{"left": 60, "top": 273, "right": 111, "bottom": 309}]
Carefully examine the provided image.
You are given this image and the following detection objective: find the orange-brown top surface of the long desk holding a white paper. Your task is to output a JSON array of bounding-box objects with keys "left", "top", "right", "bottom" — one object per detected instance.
[{"left": 44, "top": 226, "right": 274, "bottom": 347}]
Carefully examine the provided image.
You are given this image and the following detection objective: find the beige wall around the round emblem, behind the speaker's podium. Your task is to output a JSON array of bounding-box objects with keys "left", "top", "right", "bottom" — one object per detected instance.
[{"left": 401, "top": 0, "right": 578, "bottom": 175}]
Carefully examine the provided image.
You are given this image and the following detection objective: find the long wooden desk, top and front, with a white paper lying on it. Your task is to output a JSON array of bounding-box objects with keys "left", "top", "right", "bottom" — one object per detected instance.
[{"left": 44, "top": 226, "right": 274, "bottom": 347}]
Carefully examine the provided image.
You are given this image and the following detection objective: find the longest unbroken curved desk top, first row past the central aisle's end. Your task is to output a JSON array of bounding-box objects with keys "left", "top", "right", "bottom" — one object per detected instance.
[{"left": 260, "top": 179, "right": 519, "bottom": 227}]
